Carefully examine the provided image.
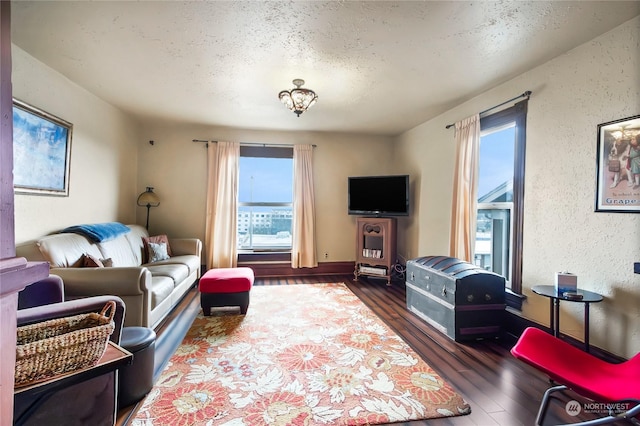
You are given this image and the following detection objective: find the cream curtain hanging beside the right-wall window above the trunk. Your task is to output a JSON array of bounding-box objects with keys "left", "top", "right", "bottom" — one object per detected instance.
[{"left": 449, "top": 114, "right": 480, "bottom": 262}]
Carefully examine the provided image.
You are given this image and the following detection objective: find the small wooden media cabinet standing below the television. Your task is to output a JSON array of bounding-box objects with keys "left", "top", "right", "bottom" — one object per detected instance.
[{"left": 353, "top": 217, "right": 397, "bottom": 285}]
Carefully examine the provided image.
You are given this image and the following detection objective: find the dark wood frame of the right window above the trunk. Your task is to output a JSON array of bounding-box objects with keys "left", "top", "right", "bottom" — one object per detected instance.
[{"left": 476, "top": 99, "right": 529, "bottom": 309}]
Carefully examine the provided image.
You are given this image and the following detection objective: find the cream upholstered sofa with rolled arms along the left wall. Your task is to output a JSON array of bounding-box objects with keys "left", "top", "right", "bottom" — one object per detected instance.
[{"left": 16, "top": 225, "right": 202, "bottom": 328}]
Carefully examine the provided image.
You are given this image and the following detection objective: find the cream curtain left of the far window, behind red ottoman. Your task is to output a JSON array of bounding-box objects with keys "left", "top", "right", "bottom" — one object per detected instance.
[{"left": 205, "top": 141, "right": 240, "bottom": 269}]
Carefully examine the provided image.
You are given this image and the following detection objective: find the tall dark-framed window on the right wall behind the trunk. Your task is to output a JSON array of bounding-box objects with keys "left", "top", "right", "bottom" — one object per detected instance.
[{"left": 474, "top": 100, "right": 527, "bottom": 308}]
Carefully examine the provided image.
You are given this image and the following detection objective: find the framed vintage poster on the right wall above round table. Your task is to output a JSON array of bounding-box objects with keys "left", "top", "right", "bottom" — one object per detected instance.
[{"left": 595, "top": 115, "right": 640, "bottom": 213}]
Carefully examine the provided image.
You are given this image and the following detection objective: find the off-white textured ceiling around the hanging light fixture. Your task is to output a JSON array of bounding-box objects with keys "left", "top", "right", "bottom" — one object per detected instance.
[{"left": 11, "top": 1, "right": 640, "bottom": 135}]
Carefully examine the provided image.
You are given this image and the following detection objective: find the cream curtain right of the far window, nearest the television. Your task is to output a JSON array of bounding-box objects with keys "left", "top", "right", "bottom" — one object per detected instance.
[{"left": 291, "top": 145, "right": 318, "bottom": 268}]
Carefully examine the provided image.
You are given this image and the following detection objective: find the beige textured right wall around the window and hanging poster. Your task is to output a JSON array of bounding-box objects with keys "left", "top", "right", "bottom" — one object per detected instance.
[{"left": 396, "top": 18, "right": 640, "bottom": 357}]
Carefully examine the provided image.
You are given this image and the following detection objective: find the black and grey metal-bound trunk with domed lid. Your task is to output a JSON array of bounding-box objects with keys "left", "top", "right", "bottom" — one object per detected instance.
[{"left": 406, "top": 256, "right": 505, "bottom": 341}]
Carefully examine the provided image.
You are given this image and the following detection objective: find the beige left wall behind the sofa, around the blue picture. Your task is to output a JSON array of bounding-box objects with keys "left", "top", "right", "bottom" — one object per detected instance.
[{"left": 11, "top": 45, "right": 139, "bottom": 244}]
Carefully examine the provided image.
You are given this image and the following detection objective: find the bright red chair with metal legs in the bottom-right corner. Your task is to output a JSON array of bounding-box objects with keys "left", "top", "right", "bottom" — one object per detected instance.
[{"left": 511, "top": 327, "right": 640, "bottom": 426}]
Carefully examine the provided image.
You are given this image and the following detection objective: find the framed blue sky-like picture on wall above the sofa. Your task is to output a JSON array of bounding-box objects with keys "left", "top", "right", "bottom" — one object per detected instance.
[{"left": 13, "top": 99, "right": 73, "bottom": 197}]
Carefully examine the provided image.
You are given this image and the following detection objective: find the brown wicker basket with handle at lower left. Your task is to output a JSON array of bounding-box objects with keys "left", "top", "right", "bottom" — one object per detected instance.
[{"left": 15, "top": 301, "right": 116, "bottom": 386}]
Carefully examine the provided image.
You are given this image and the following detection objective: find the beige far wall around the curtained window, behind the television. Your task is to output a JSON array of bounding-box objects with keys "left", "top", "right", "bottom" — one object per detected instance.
[{"left": 137, "top": 121, "right": 393, "bottom": 261}]
